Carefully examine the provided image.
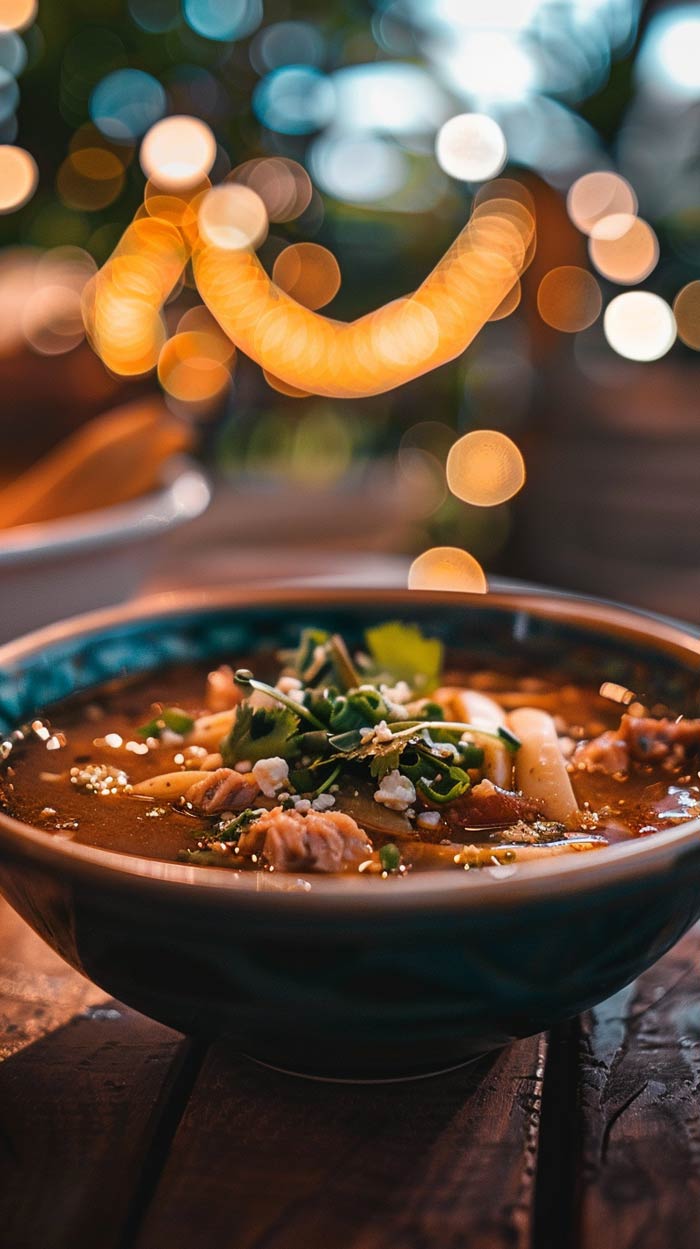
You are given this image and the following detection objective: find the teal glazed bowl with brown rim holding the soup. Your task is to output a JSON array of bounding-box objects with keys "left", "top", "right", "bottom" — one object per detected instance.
[{"left": 0, "top": 588, "right": 700, "bottom": 1079}]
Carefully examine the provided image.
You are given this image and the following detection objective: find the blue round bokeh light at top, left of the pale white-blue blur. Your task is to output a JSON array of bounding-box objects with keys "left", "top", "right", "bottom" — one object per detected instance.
[{"left": 253, "top": 65, "right": 335, "bottom": 135}]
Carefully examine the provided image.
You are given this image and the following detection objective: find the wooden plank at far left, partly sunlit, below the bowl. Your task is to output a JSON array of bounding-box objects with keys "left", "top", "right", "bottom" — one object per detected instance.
[{"left": 0, "top": 903, "right": 192, "bottom": 1249}]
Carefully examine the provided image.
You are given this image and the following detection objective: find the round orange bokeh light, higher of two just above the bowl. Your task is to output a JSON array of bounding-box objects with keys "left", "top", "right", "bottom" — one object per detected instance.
[{"left": 445, "top": 430, "right": 525, "bottom": 507}]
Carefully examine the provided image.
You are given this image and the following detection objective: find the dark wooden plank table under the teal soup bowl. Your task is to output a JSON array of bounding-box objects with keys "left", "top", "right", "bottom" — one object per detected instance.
[{"left": 0, "top": 903, "right": 700, "bottom": 1249}]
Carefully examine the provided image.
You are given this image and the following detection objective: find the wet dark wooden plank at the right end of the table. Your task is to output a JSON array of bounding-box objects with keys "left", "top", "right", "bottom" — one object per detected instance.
[{"left": 579, "top": 928, "right": 700, "bottom": 1249}]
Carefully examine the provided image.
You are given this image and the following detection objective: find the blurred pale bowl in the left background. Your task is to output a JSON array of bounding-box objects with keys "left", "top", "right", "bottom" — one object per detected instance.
[{"left": 0, "top": 457, "right": 210, "bottom": 642}]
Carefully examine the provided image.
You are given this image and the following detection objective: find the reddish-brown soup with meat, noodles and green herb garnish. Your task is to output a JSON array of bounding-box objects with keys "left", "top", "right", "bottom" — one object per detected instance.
[{"left": 0, "top": 622, "right": 700, "bottom": 879}]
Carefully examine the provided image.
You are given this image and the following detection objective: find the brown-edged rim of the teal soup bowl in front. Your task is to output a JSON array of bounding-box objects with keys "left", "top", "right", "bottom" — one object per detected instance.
[{"left": 0, "top": 582, "right": 700, "bottom": 917}]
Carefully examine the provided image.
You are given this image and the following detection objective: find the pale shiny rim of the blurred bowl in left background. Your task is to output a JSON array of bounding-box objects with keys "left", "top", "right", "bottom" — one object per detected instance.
[{"left": 0, "top": 456, "right": 211, "bottom": 572}]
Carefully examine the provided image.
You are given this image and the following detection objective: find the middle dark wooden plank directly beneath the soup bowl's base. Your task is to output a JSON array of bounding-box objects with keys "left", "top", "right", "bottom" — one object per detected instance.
[{"left": 136, "top": 1039, "right": 544, "bottom": 1249}]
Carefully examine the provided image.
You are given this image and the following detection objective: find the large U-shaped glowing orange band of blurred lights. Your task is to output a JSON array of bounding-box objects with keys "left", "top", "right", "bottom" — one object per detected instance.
[{"left": 194, "top": 198, "right": 534, "bottom": 398}]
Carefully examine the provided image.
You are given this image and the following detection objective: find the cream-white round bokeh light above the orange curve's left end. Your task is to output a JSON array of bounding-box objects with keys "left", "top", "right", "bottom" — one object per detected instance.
[{"left": 140, "top": 115, "right": 216, "bottom": 190}]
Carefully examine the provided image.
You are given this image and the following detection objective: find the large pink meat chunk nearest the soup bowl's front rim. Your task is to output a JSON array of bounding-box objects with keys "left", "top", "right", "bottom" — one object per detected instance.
[{"left": 239, "top": 807, "right": 373, "bottom": 872}]
